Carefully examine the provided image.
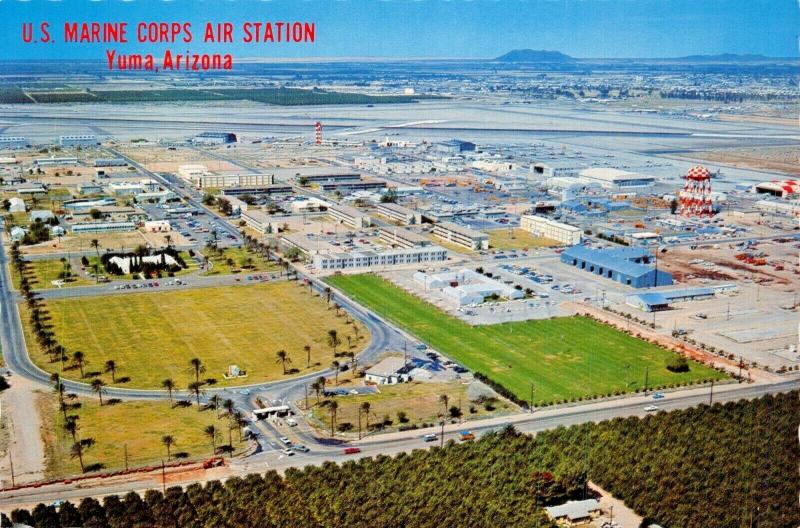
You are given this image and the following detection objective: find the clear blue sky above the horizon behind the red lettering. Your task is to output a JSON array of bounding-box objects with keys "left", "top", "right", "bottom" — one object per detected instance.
[{"left": 0, "top": 0, "right": 800, "bottom": 59}]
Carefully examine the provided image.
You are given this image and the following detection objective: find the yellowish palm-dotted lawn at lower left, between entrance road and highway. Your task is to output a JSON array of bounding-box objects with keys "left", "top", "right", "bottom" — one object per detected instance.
[{"left": 39, "top": 394, "right": 246, "bottom": 477}]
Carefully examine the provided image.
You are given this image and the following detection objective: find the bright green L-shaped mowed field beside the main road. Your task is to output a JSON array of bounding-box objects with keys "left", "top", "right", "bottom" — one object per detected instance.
[{"left": 328, "top": 274, "right": 724, "bottom": 404}]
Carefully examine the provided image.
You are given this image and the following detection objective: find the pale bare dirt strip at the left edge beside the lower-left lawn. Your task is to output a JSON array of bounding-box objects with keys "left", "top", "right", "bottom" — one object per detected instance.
[{"left": 0, "top": 376, "right": 45, "bottom": 485}]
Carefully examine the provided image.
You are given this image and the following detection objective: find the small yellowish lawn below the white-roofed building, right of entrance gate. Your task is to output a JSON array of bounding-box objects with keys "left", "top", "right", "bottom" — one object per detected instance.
[{"left": 301, "top": 381, "right": 519, "bottom": 434}]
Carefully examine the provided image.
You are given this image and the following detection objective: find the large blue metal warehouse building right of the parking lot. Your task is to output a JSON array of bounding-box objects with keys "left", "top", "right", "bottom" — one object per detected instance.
[{"left": 561, "top": 246, "right": 672, "bottom": 288}]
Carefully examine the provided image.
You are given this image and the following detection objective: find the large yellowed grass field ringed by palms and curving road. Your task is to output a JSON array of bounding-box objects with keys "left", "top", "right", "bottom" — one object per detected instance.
[{"left": 25, "top": 282, "right": 369, "bottom": 389}]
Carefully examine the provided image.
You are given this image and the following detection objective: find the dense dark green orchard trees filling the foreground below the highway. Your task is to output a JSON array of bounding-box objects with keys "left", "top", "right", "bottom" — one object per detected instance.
[{"left": 9, "top": 391, "right": 800, "bottom": 528}]
